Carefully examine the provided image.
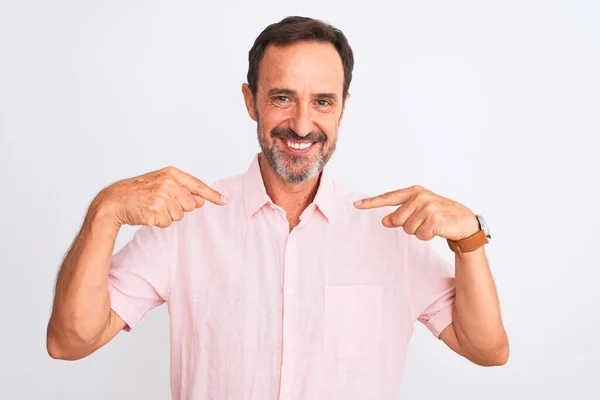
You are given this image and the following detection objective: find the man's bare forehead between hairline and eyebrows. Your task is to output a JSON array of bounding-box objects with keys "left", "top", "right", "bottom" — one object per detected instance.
[{"left": 258, "top": 42, "right": 344, "bottom": 93}]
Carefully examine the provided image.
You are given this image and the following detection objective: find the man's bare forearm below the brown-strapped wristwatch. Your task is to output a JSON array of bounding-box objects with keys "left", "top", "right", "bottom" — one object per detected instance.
[{"left": 453, "top": 248, "right": 508, "bottom": 364}]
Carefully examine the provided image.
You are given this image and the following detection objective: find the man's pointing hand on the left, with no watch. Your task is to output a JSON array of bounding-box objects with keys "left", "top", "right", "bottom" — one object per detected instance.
[{"left": 93, "top": 167, "right": 227, "bottom": 228}]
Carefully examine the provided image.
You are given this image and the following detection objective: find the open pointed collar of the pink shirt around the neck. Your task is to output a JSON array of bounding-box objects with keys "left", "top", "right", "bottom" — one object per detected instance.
[{"left": 242, "top": 153, "right": 333, "bottom": 221}]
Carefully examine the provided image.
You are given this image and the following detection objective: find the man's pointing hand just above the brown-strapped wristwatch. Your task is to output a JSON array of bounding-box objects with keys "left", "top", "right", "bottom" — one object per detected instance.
[{"left": 354, "top": 186, "right": 479, "bottom": 240}]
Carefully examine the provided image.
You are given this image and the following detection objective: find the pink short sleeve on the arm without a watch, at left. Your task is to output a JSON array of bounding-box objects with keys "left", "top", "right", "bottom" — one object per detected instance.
[{"left": 108, "top": 226, "right": 173, "bottom": 331}]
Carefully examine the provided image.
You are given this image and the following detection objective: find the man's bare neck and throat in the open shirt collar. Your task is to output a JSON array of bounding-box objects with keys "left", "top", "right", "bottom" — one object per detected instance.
[{"left": 259, "top": 155, "right": 320, "bottom": 229}]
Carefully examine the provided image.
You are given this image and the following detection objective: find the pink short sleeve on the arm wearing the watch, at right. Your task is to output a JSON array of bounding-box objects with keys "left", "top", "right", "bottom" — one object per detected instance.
[{"left": 406, "top": 236, "right": 456, "bottom": 337}]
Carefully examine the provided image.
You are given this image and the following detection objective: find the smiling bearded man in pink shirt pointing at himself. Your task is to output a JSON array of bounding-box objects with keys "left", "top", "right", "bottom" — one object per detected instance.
[{"left": 47, "top": 17, "right": 508, "bottom": 400}]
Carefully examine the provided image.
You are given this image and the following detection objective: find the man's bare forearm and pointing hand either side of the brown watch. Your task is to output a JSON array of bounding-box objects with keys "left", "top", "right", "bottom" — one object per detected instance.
[{"left": 355, "top": 186, "right": 509, "bottom": 366}]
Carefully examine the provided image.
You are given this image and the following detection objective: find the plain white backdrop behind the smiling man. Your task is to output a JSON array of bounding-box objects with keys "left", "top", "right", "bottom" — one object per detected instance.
[{"left": 0, "top": 0, "right": 600, "bottom": 400}]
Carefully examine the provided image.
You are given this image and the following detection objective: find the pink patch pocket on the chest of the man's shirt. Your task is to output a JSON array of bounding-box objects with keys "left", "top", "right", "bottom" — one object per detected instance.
[{"left": 323, "top": 285, "right": 383, "bottom": 358}]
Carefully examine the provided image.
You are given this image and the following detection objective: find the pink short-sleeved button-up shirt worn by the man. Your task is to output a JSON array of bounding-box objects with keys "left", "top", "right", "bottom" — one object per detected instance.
[{"left": 109, "top": 152, "right": 455, "bottom": 400}]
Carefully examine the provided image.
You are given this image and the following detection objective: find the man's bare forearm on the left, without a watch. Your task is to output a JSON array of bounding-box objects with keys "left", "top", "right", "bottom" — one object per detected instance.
[{"left": 47, "top": 203, "right": 119, "bottom": 354}]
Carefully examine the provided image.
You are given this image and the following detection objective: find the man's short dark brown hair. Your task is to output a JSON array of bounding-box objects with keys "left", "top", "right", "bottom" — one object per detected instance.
[{"left": 247, "top": 17, "right": 354, "bottom": 99}]
